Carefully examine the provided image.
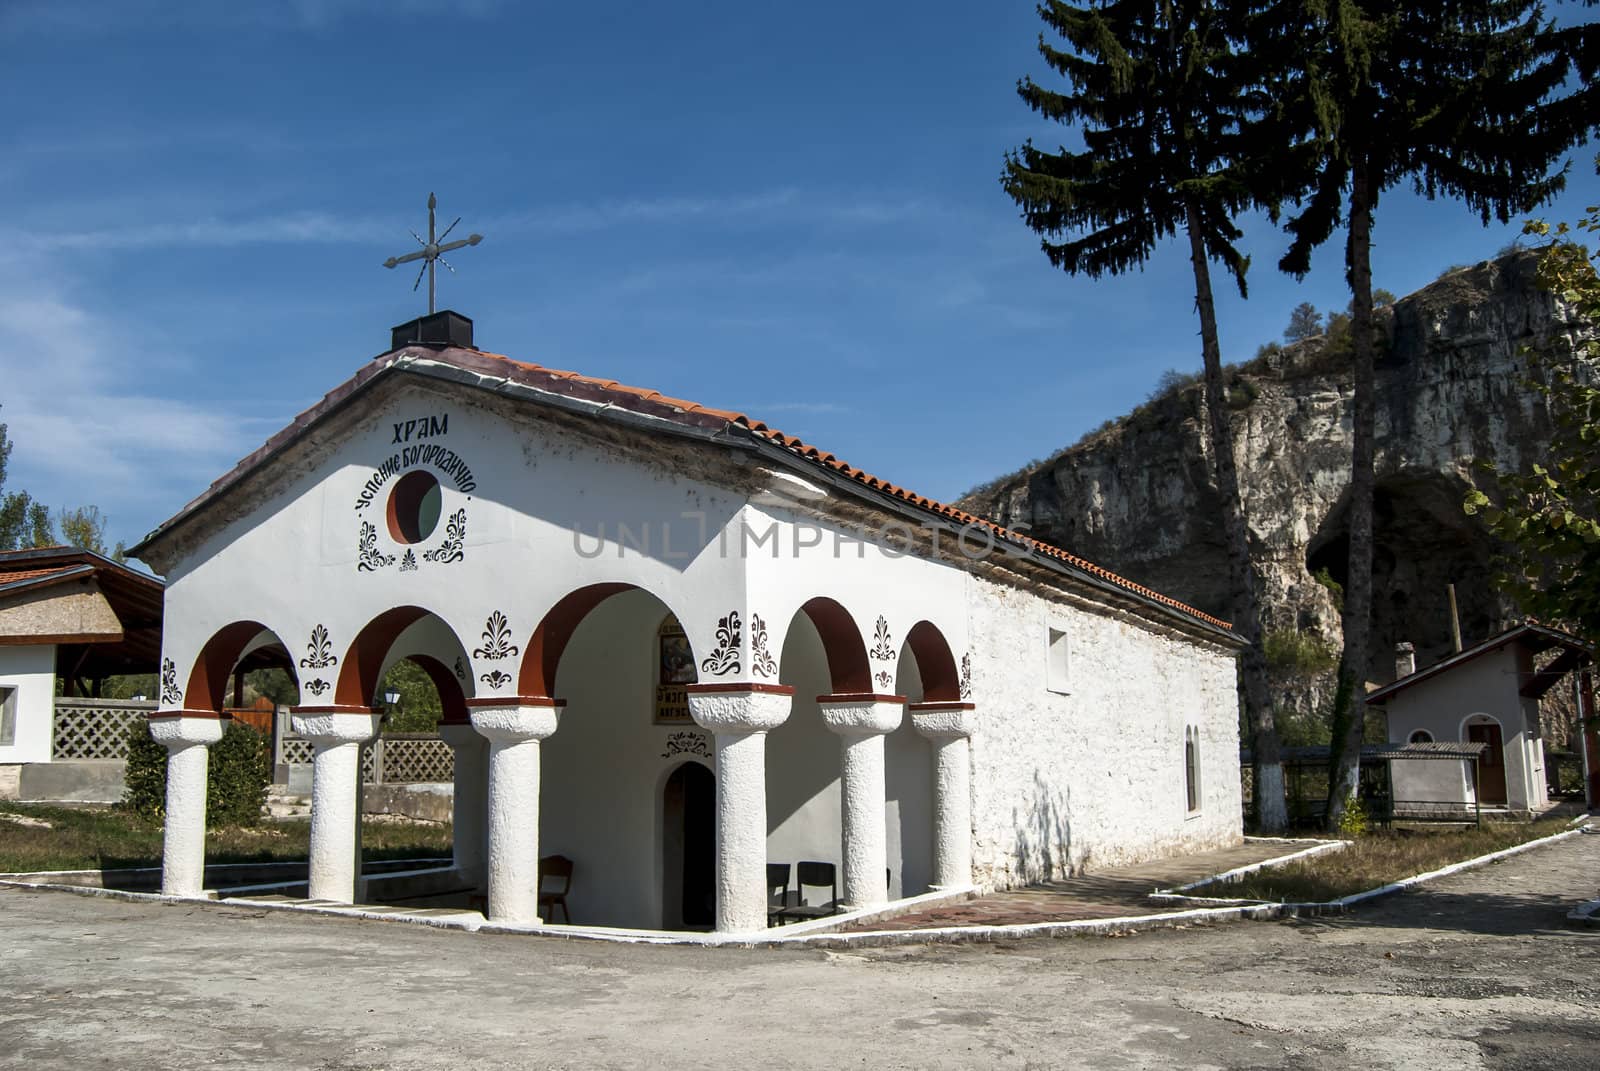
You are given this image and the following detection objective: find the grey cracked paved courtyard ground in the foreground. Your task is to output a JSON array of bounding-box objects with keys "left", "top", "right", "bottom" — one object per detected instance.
[{"left": 0, "top": 836, "right": 1600, "bottom": 1071}]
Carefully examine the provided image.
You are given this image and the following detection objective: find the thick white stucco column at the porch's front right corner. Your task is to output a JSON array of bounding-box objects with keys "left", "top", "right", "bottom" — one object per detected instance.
[{"left": 688, "top": 684, "right": 794, "bottom": 933}]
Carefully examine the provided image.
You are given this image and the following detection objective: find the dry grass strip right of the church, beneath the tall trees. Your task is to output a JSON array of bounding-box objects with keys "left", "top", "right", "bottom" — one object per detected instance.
[{"left": 1222, "top": 818, "right": 1570, "bottom": 903}]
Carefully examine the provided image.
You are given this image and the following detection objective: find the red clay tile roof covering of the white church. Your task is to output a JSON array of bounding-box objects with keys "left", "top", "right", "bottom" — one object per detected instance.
[{"left": 140, "top": 346, "right": 1234, "bottom": 632}]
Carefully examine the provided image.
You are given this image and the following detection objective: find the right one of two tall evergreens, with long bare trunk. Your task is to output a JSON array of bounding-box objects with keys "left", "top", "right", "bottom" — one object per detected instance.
[{"left": 1245, "top": 0, "right": 1600, "bottom": 828}]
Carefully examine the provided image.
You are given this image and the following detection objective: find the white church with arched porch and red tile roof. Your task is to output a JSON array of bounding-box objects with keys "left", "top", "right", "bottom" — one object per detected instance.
[{"left": 134, "top": 312, "right": 1242, "bottom": 933}]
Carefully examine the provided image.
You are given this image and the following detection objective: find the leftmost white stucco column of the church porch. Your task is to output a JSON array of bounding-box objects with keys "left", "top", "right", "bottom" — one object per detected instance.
[{"left": 150, "top": 711, "right": 222, "bottom": 897}]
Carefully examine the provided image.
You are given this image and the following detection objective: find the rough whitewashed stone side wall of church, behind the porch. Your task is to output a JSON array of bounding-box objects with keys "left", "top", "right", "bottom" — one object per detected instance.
[{"left": 968, "top": 578, "right": 1243, "bottom": 887}]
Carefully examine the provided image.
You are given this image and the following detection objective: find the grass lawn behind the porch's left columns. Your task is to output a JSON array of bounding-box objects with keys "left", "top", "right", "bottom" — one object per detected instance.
[{"left": 0, "top": 804, "right": 450, "bottom": 874}]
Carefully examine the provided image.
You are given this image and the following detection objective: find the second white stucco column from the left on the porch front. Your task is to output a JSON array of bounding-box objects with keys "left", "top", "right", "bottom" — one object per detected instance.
[{"left": 291, "top": 706, "right": 379, "bottom": 903}]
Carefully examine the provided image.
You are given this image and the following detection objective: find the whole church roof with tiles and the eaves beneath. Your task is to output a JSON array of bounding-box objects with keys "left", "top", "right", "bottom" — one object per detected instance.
[{"left": 130, "top": 344, "right": 1238, "bottom": 645}]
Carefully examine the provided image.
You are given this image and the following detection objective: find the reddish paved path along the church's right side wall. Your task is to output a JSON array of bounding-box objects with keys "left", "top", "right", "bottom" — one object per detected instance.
[{"left": 840, "top": 840, "right": 1314, "bottom": 932}]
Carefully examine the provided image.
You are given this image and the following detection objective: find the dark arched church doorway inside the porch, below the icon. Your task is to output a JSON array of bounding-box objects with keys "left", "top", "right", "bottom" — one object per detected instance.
[{"left": 661, "top": 762, "right": 717, "bottom": 930}]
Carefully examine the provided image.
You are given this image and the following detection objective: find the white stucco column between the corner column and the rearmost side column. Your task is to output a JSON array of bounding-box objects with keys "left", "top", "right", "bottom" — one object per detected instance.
[{"left": 816, "top": 695, "right": 906, "bottom": 909}]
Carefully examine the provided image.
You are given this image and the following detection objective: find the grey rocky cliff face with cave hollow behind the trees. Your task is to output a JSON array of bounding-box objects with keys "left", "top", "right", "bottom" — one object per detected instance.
[{"left": 962, "top": 251, "right": 1592, "bottom": 709}]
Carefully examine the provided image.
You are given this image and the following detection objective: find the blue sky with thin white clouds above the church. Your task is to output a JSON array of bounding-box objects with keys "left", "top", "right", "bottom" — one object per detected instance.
[{"left": 0, "top": 0, "right": 1600, "bottom": 543}]
